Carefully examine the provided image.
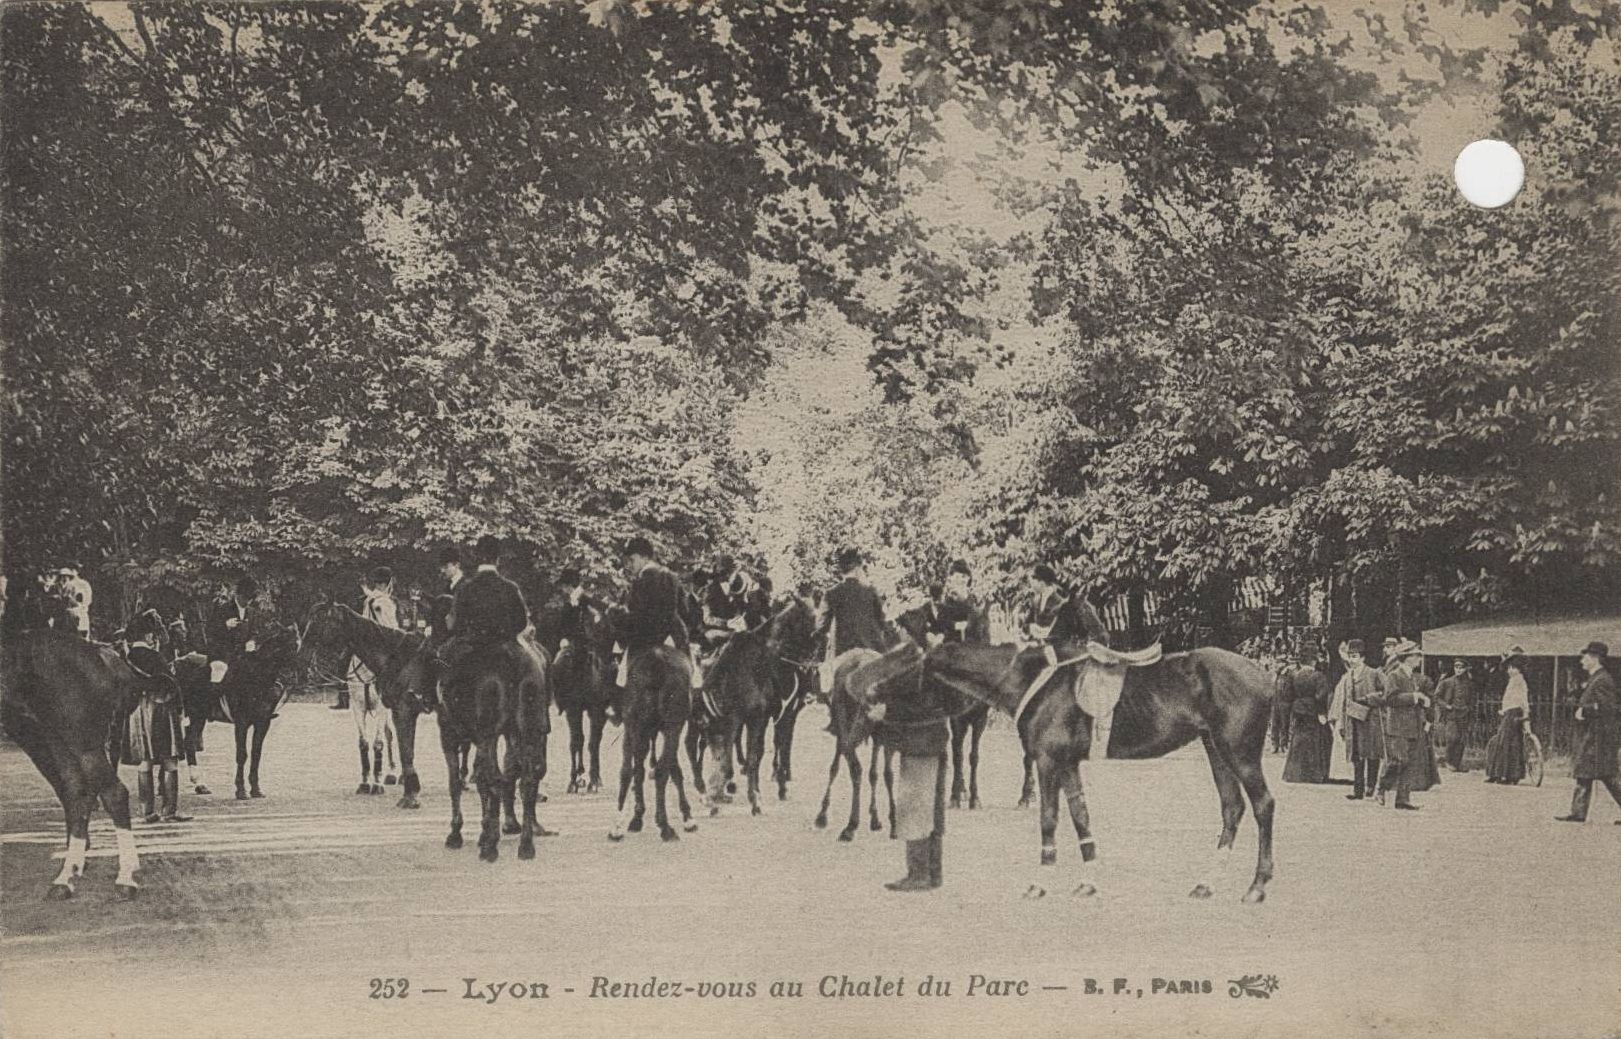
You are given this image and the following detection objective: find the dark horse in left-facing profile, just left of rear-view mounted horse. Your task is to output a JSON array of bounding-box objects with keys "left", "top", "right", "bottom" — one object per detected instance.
[{"left": 305, "top": 603, "right": 433, "bottom": 809}]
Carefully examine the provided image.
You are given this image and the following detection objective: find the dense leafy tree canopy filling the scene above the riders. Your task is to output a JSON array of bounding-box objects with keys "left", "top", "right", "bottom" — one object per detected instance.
[{"left": 0, "top": 0, "right": 1621, "bottom": 629}]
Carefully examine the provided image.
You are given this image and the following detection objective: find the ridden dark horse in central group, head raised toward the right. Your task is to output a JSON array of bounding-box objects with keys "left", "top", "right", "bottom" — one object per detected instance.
[{"left": 692, "top": 598, "right": 817, "bottom": 815}]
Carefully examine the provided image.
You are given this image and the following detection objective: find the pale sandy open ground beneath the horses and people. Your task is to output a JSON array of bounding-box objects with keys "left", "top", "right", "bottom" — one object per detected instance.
[{"left": 0, "top": 703, "right": 1621, "bottom": 1039}]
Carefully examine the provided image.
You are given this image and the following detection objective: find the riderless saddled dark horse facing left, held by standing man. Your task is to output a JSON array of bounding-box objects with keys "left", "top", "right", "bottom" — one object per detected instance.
[{"left": 922, "top": 643, "right": 1272, "bottom": 903}]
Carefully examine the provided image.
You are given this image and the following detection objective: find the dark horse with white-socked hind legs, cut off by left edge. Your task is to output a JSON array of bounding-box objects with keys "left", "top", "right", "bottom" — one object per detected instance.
[{"left": 0, "top": 629, "right": 141, "bottom": 900}]
